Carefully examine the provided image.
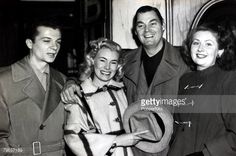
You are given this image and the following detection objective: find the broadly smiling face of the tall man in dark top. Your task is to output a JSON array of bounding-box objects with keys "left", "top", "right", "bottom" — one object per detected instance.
[{"left": 135, "top": 11, "right": 164, "bottom": 48}]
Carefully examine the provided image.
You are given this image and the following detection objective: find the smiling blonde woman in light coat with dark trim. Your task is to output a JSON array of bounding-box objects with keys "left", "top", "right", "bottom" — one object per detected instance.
[{"left": 65, "top": 38, "right": 142, "bottom": 156}]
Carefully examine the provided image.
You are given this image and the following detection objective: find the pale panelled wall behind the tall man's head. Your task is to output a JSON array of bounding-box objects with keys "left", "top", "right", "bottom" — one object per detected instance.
[{"left": 112, "top": 0, "right": 209, "bottom": 49}]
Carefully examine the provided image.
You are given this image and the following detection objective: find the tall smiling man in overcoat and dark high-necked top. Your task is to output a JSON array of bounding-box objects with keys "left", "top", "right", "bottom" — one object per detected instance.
[{"left": 123, "top": 6, "right": 187, "bottom": 156}]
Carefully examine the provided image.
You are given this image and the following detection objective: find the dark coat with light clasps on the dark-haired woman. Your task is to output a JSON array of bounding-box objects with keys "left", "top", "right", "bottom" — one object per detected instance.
[{"left": 168, "top": 66, "right": 236, "bottom": 156}]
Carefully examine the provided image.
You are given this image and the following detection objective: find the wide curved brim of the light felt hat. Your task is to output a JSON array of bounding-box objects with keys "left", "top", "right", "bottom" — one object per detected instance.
[{"left": 123, "top": 101, "right": 173, "bottom": 153}]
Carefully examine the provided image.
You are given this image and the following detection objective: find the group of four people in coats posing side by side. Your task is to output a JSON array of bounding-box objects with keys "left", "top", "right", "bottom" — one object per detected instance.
[{"left": 0, "top": 6, "right": 236, "bottom": 156}]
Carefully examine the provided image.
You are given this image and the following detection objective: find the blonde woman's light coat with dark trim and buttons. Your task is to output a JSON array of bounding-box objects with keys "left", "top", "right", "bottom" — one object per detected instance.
[{"left": 65, "top": 78, "right": 133, "bottom": 156}]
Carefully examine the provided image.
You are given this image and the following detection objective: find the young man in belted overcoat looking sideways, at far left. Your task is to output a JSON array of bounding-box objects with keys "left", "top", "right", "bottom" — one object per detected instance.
[{"left": 0, "top": 20, "right": 65, "bottom": 156}]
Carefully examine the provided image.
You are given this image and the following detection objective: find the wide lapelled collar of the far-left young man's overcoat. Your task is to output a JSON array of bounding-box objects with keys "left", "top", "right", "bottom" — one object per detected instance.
[{"left": 12, "top": 57, "right": 63, "bottom": 121}]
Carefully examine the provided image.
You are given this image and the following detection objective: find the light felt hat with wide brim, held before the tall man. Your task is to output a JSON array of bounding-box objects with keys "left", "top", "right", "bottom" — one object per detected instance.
[{"left": 123, "top": 101, "right": 173, "bottom": 153}]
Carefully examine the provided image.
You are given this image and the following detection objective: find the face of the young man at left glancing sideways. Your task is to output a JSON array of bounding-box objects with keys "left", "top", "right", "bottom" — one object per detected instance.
[{"left": 27, "top": 26, "right": 61, "bottom": 63}]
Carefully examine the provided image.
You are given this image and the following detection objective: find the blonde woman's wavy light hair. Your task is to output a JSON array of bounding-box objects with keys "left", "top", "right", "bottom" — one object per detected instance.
[{"left": 79, "top": 38, "right": 124, "bottom": 81}]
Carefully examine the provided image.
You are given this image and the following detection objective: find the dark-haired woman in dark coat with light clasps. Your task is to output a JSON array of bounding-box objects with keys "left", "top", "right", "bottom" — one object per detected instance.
[{"left": 168, "top": 24, "right": 236, "bottom": 156}]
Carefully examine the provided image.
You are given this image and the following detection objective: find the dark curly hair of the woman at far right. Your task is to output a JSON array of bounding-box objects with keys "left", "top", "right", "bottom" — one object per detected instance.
[{"left": 181, "top": 22, "right": 236, "bottom": 70}]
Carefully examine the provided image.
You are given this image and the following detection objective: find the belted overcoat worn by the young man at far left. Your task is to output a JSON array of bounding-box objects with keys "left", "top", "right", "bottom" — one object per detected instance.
[{"left": 0, "top": 58, "right": 65, "bottom": 156}]
